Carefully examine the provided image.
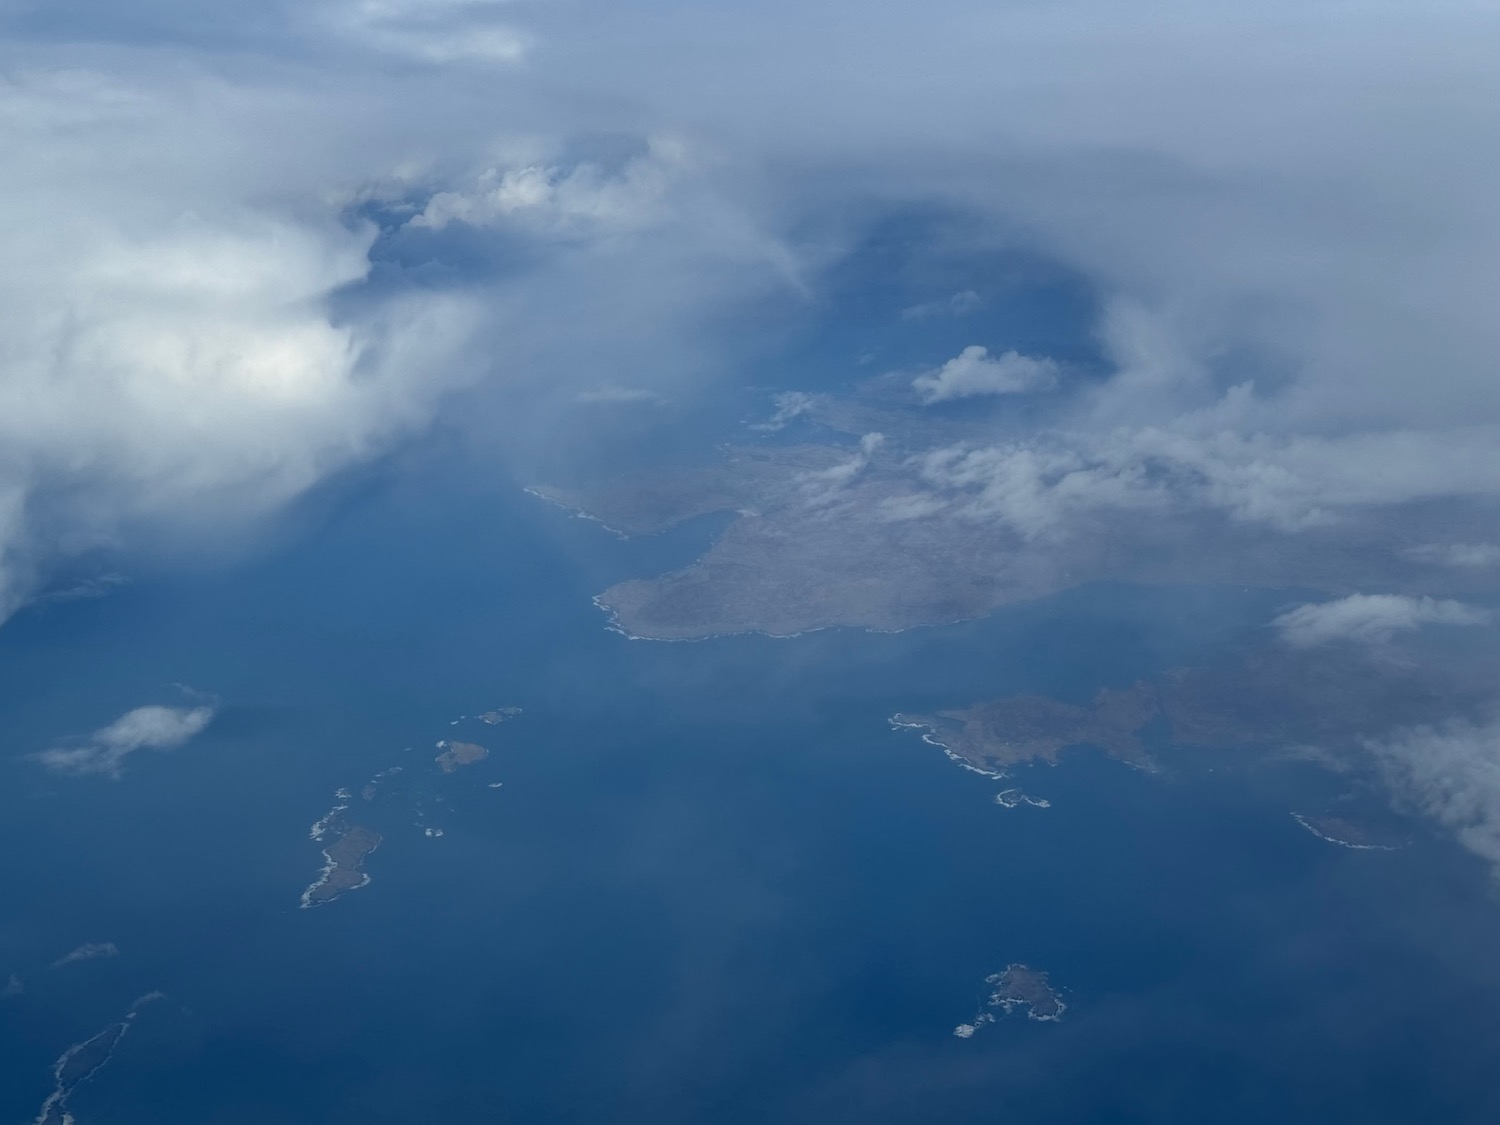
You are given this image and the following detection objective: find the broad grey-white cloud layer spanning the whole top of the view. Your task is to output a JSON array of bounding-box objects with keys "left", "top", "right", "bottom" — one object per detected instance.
[{"left": 0, "top": 0, "right": 1500, "bottom": 627}]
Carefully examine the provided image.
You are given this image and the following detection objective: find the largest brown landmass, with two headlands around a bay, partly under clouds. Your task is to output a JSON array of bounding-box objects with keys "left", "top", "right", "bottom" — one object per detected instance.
[{"left": 530, "top": 405, "right": 1497, "bottom": 641}]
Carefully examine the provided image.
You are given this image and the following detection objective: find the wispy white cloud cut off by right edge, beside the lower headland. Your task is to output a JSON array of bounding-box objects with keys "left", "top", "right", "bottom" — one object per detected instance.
[{"left": 1367, "top": 723, "right": 1500, "bottom": 879}]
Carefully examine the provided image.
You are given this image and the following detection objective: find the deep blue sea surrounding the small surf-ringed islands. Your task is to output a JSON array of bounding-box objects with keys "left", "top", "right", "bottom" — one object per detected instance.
[{"left": 0, "top": 444, "right": 1500, "bottom": 1125}]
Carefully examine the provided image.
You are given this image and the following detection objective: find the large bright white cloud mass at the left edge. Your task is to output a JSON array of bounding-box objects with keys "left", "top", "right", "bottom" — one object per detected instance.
[{"left": 0, "top": 69, "right": 476, "bottom": 620}]
